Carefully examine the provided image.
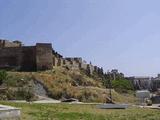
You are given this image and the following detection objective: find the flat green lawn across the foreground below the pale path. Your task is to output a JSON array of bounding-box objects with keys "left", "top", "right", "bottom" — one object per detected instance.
[{"left": 0, "top": 102, "right": 160, "bottom": 120}]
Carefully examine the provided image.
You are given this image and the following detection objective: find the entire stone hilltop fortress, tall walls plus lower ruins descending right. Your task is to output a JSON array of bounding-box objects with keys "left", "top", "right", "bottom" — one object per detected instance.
[{"left": 0, "top": 40, "right": 100, "bottom": 73}]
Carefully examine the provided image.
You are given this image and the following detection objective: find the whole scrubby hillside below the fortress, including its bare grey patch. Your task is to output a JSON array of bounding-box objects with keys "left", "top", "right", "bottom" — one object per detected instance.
[{"left": 1, "top": 67, "right": 135, "bottom": 103}]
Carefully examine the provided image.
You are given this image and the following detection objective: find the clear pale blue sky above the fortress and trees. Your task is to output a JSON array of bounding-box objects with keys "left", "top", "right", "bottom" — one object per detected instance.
[{"left": 0, "top": 0, "right": 160, "bottom": 75}]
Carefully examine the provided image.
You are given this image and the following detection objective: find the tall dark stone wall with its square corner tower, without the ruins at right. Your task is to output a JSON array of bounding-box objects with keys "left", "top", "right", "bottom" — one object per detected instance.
[{"left": 0, "top": 40, "right": 53, "bottom": 71}]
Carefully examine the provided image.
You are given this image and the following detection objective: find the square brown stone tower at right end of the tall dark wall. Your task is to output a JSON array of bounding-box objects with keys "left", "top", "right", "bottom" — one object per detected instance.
[{"left": 36, "top": 43, "right": 53, "bottom": 70}]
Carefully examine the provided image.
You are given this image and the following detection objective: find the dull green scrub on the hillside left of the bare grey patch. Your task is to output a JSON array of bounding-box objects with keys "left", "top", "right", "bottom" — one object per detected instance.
[{"left": 0, "top": 72, "right": 36, "bottom": 101}]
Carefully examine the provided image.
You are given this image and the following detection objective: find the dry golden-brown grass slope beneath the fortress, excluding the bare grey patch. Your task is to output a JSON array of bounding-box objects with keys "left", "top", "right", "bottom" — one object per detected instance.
[{"left": 6, "top": 68, "right": 135, "bottom": 103}]
